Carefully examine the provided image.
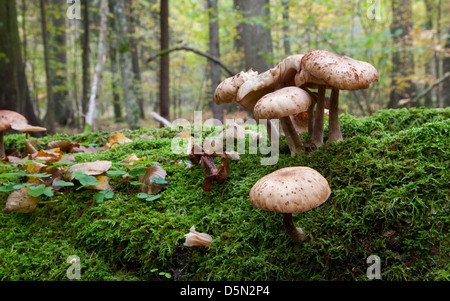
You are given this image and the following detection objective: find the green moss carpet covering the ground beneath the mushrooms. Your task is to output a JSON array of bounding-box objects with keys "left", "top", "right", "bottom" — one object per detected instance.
[{"left": 0, "top": 108, "right": 450, "bottom": 281}]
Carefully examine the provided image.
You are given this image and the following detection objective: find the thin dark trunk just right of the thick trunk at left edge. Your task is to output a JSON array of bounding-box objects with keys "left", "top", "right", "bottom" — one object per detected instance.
[{"left": 40, "top": 0, "right": 55, "bottom": 134}]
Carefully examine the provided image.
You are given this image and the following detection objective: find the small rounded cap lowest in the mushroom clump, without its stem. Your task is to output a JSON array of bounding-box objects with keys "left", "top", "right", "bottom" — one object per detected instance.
[{"left": 253, "top": 87, "right": 312, "bottom": 120}]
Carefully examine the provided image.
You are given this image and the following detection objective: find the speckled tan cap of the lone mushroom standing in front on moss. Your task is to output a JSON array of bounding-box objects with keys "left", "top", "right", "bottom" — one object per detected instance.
[{"left": 250, "top": 166, "right": 331, "bottom": 213}]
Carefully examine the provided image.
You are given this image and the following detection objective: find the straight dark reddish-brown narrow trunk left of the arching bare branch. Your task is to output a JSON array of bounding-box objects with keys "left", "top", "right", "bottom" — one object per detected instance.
[{"left": 159, "top": 0, "right": 170, "bottom": 127}]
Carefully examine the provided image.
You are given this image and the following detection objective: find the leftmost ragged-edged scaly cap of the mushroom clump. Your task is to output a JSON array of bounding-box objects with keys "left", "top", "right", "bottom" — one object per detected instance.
[{"left": 214, "top": 69, "right": 258, "bottom": 105}]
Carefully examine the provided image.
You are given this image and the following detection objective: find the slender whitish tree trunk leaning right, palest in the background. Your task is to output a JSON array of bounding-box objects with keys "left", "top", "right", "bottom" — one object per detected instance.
[{"left": 84, "top": 0, "right": 108, "bottom": 133}]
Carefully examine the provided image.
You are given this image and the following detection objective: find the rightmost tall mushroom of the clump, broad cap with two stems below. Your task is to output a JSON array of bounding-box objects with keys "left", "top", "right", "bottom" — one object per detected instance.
[{"left": 295, "top": 50, "right": 379, "bottom": 146}]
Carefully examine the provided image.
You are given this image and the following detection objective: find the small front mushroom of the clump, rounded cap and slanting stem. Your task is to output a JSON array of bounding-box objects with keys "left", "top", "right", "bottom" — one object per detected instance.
[{"left": 253, "top": 87, "right": 312, "bottom": 156}]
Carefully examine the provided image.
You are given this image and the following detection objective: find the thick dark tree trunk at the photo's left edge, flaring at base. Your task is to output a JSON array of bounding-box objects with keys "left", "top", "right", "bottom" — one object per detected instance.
[{"left": 0, "top": 0, "right": 41, "bottom": 127}]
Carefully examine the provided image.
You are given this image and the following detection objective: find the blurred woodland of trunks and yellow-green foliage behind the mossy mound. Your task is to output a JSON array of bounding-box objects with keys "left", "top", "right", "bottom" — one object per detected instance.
[{"left": 0, "top": 0, "right": 450, "bottom": 133}]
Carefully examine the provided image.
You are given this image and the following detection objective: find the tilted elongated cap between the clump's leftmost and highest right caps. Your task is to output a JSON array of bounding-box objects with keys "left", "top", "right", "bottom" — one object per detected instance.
[{"left": 236, "top": 54, "right": 303, "bottom": 110}]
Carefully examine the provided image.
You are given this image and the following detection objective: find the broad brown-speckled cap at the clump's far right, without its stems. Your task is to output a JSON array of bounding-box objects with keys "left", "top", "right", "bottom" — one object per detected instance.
[{"left": 301, "top": 50, "right": 378, "bottom": 90}]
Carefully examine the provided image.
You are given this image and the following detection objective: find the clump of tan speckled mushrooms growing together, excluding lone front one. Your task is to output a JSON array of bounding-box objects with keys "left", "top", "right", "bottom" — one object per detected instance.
[{"left": 214, "top": 50, "right": 378, "bottom": 156}]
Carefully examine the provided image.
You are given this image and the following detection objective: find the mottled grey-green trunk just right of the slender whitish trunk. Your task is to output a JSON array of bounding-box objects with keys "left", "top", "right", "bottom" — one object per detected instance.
[{"left": 114, "top": 0, "right": 140, "bottom": 130}]
